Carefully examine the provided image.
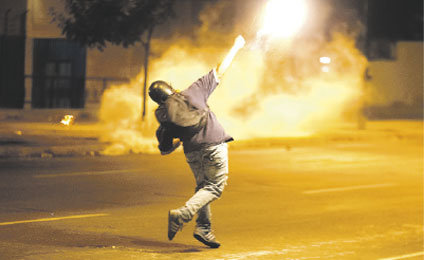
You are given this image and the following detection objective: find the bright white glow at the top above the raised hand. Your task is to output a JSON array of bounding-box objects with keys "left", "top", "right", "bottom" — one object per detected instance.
[{"left": 259, "top": 0, "right": 307, "bottom": 38}]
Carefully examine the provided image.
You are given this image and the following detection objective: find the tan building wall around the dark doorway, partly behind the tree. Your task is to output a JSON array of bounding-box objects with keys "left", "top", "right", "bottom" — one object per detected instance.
[{"left": 23, "top": 0, "right": 201, "bottom": 107}]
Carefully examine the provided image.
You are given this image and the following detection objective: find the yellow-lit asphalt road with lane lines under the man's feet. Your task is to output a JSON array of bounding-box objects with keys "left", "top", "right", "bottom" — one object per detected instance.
[{"left": 0, "top": 139, "right": 424, "bottom": 260}]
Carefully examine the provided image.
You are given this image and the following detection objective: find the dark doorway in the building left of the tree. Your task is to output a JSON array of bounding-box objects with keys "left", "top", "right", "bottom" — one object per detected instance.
[{"left": 32, "top": 39, "right": 86, "bottom": 108}]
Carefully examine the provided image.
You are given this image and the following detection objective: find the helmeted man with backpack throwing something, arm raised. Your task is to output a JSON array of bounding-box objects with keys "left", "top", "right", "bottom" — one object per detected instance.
[{"left": 149, "top": 36, "right": 245, "bottom": 248}]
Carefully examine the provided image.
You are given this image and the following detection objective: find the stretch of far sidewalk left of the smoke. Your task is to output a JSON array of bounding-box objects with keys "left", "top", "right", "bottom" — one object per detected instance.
[{"left": 0, "top": 109, "right": 106, "bottom": 158}]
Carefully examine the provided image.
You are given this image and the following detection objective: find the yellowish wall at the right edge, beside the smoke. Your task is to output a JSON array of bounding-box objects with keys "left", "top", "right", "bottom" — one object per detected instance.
[{"left": 365, "top": 42, "right": 424, "bottom": 119}]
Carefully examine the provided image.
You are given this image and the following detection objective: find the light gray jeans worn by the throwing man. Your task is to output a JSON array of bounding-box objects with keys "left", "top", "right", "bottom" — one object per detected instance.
[{"left": 179, "top": 143, "right": 229, "bottom": 226}]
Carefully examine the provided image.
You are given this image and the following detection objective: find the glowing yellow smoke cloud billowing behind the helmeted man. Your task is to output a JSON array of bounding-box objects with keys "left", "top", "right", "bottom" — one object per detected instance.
[{"left": 100, "top": 1, "right": 366, "bottom": 154}]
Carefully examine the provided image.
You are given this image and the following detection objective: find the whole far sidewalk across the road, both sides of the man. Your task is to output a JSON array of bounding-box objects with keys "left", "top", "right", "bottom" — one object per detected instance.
[{"left": 0, "top": 109, "right": 423, "bottom": 159}]
